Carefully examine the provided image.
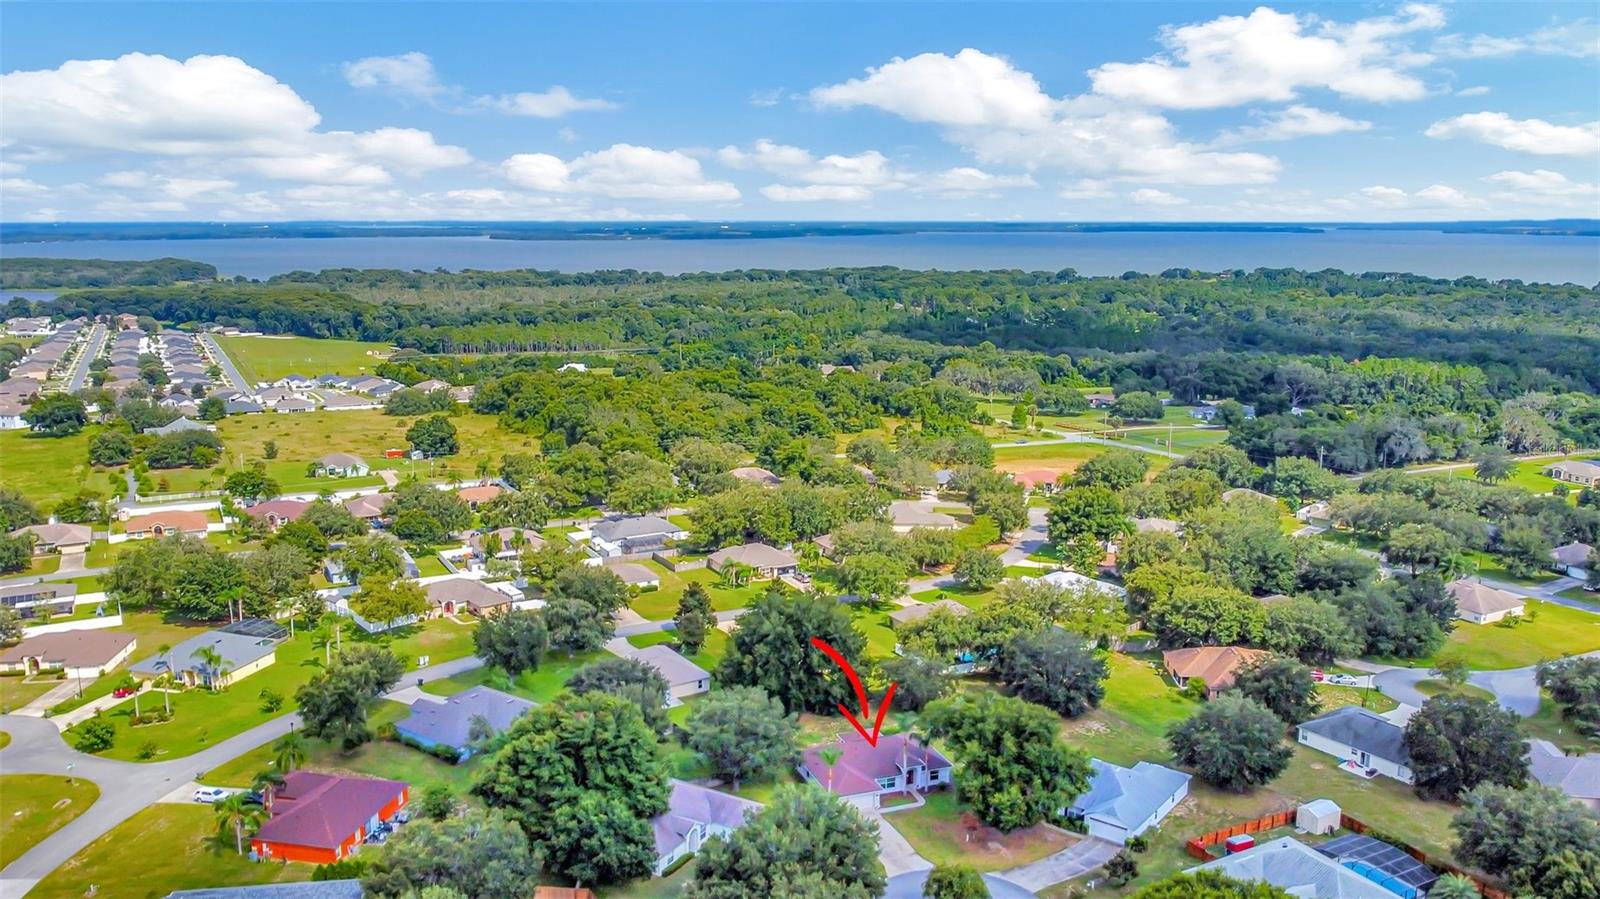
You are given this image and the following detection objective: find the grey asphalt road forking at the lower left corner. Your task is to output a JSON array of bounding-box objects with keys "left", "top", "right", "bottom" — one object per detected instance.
[{"left": 0, "top": 656, "right": 483, "bottom": 899}]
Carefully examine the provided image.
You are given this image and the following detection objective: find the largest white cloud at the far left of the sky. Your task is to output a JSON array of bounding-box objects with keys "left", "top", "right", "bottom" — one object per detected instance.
[{"left": 0, "top": 53, "right": 472, "bottom": 184}]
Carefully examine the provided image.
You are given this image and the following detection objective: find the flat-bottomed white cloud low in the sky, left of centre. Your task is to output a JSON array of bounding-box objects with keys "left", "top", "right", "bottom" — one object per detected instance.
[{"left": 501, "top": 144, "right": 739, "bottom": 202}]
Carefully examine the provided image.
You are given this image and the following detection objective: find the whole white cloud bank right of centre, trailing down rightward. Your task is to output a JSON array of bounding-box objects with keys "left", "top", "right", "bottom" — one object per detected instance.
[{"left": 811, "top": 50, "right": 1278, "bottom": 184}]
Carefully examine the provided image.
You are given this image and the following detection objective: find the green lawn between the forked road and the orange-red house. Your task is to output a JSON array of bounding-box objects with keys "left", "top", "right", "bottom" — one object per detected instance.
[{"left": 29, "top": 803, "right": 314, "bottom": 899}]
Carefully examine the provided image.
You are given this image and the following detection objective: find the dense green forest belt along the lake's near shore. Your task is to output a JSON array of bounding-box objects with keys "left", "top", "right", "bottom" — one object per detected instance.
[{"left": 8, "top": 260, "right": 1600, "bottom": 470}]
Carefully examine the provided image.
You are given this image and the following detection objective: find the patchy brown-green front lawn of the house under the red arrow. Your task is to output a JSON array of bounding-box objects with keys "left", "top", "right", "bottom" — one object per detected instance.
[{"left": 886, "top": 790, "right": 1077, "bottom": 870}]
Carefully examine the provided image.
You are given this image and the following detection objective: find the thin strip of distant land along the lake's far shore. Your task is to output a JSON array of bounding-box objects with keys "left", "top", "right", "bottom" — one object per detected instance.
[{"left": 0, "top": 219, "right": 1600, "bottom": 245}]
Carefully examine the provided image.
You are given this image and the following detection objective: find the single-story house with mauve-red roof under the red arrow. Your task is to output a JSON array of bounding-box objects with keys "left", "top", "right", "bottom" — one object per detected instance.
[{"left": 797, "top": 734, "right": 954, "bottom": 809}]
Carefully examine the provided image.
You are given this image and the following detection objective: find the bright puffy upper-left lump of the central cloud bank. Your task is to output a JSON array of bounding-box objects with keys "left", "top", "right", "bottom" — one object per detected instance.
[{"left": 811, "top": 48, "right": 1056, "bottom": 128}]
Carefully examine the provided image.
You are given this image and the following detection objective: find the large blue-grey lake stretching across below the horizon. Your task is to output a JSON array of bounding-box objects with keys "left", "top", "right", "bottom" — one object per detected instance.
[{"left": 0, "top": 230, "right": 1600, "bottom": 285}]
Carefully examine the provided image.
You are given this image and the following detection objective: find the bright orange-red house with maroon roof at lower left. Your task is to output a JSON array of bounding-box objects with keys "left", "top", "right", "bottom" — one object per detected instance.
[{"left": 250, "top": 771, "right": 411, "bottom": 864}]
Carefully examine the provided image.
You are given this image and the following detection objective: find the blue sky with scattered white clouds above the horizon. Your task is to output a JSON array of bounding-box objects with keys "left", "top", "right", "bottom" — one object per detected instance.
[{"left": 0, "top": 2, "right": 1600, "bottom": 221}]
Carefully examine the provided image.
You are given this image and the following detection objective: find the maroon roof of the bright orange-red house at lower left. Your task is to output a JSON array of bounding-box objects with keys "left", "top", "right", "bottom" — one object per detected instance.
[{"left": 256, "top": 771, "right": 406, "bottom": 849}]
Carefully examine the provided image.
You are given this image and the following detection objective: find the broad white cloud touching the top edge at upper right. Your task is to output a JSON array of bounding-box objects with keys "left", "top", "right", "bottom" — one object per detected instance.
[{"left": 1090, "top": 3, "right": 1445, "bottom": 109}]
